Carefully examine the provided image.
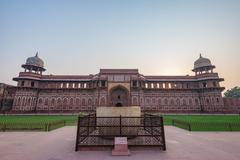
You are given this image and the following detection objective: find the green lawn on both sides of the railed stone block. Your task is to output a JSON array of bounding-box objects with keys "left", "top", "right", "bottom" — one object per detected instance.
[{"left": 0, "top": 115, "right": 240, "bottom": 131}]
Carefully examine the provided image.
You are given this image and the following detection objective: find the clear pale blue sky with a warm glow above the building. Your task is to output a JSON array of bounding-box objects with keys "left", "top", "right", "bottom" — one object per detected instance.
[{"left": 0, "top": 0, "right": 240, "bottom": 88}]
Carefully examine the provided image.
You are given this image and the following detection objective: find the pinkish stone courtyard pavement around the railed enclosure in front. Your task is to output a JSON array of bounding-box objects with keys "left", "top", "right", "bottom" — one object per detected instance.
[{"left": 0, "top": 126, "right": 240, "bottom": 160}]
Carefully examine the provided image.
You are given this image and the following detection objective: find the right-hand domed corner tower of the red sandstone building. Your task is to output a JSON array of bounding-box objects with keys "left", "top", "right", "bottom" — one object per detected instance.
[{"left": 192, "top": 54, "right": 225, "bottom": 112}]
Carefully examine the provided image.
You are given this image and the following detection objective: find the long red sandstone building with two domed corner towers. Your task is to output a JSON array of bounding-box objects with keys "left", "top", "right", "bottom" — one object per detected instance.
[{"left": 13, "top": 54, "right": 226, "bottom": 112}]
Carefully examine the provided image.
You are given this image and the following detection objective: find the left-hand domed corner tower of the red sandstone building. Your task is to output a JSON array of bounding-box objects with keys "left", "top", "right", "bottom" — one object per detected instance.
[{"left": 13, "top": 52, "right": 46, "bottom": 112}]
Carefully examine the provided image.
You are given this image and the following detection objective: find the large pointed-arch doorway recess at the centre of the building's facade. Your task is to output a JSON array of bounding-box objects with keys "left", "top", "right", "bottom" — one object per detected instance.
[{"left": 110, "top": 86, "right": 129, "bottom": 107}]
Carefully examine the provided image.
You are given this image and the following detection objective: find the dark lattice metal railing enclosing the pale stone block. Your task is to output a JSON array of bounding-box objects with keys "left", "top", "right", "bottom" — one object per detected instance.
[{"left": 75, "top": 114, "right": 166, "bottom": 151}]
